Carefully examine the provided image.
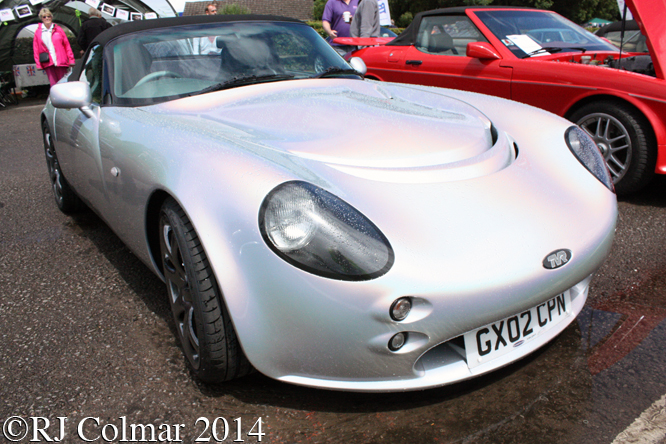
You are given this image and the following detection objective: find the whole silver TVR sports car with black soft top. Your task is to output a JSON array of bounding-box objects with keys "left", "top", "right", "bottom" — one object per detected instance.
[{"left": 41, "top": 15, "right": 617, "bottom": 391}]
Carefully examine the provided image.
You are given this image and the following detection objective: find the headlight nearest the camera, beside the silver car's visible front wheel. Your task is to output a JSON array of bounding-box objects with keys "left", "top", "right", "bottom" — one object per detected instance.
[{"left": 259, "top": 181, "right": 394, "bottom": 281}]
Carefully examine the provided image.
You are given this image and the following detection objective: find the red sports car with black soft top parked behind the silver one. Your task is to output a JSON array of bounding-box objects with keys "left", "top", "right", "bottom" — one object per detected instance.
[{"left": 348, "top": 0, "right": 666, "bottom": 194}]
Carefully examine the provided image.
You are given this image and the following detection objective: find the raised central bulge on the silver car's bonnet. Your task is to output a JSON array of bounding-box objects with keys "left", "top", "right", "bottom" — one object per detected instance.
[{"left": 153, "top": 79, "right": 510, "bottom": 177}]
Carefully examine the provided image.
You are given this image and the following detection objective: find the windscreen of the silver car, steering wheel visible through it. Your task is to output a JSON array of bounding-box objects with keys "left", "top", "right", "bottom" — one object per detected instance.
[{"left": 104, "top": 22, "right": 350, "bottom": 106}]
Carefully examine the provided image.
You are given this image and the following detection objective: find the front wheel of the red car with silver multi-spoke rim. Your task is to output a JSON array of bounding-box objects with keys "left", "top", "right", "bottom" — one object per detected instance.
[{"left": 569, "top": 100, "right": 657, "bottom": 195}]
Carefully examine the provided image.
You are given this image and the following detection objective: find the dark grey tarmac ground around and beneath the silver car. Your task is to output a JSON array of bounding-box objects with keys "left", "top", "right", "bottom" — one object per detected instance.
[{"left": 0, "top": 101, "right": 666, "bottom": 444}]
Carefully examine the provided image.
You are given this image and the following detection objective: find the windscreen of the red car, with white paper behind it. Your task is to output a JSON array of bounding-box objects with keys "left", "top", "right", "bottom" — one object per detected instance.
[{"left": 474, "top": 10, "right": 616, "bottom": 58}]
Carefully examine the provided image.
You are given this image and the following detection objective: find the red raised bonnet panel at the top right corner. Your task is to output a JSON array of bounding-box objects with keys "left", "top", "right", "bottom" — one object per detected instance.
[{"left": 626, "top": 0, "right": 666, "bottom": 79}]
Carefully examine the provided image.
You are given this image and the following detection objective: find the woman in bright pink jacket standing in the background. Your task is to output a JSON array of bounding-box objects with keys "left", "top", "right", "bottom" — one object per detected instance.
[{"left": 32, "top": 8, "right": 75, "bottom": 86}]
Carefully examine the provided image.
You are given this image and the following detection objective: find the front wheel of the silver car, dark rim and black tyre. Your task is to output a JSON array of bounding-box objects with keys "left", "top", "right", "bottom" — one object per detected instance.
[{"left": 159, "top": 198, "right": 252, "bottom": 383}]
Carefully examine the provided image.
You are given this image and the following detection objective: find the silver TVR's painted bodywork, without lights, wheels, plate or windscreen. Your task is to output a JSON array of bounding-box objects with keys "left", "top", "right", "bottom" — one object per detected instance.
[{"left": 44, "top": 79, "right": 617, "bottom": 391}]
